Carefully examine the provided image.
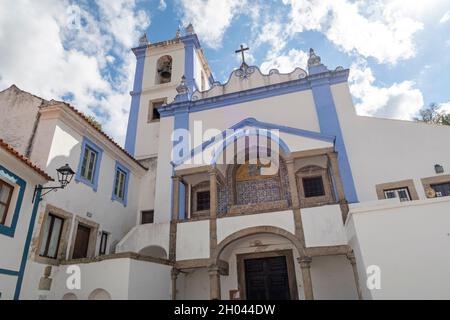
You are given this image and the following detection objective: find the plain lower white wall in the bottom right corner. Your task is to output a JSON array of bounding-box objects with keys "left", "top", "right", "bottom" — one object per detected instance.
[{"left": 346, "top": 198, "right": 450, "bottom": 299}]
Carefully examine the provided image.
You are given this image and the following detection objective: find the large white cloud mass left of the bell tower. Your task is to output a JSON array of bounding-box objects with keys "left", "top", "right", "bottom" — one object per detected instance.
[{"left": 0, "top": 0, "right": 149, "bottom": 143}]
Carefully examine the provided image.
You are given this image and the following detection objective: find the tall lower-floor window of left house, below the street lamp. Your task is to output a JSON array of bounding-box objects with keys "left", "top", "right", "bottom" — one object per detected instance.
[{"left": 39, "top": 214, "right": 64, "bottom": 259}]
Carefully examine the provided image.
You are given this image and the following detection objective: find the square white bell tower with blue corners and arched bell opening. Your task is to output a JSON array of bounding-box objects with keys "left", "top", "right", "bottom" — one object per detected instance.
[{"left": 125, "top": 24, "right": 214, "bottom": 159}]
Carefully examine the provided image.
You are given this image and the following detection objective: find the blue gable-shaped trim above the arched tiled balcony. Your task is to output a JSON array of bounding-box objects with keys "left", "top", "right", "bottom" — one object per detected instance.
[{"left": 172, "top": 118, "right": 336, "bottom": 166}]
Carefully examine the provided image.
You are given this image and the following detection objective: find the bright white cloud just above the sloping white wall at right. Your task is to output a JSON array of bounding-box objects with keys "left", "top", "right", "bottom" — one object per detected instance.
[{"left": 349, "top": 61, "right": 424, "bottom": 120}]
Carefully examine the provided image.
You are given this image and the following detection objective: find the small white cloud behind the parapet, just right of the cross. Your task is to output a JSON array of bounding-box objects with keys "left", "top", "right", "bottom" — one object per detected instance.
[{"left": 261, "top": 49, "right": 308, "bottom": 73}]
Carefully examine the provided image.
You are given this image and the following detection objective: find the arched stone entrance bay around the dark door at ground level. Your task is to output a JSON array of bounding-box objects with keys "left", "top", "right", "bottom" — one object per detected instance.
[{"left": 213, "top": 226, "right": 304, "bottom": 300}]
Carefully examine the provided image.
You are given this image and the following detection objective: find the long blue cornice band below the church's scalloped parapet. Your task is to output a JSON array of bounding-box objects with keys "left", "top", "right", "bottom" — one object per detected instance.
[{"left": 160, "top": 69, "right": 349, "bottom": 117}]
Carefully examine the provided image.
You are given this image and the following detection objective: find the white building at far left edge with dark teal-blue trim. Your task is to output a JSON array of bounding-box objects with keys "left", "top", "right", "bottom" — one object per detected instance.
[{"left": 0, "top": 139, "right": 53, "bottom": 300}]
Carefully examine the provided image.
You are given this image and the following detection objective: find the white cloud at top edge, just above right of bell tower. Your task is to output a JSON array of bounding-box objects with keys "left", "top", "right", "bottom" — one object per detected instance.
[{"left": 179, "top": 0, "right": 247, "bottom": 48}]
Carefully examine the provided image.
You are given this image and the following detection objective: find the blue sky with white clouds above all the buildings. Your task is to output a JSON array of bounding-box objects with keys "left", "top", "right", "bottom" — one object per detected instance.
[{"left": 0, "top": 0, "right": 450, "bottom": 144}]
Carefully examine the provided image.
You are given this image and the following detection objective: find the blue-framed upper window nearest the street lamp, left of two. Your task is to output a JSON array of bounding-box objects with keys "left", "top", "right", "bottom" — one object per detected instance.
[{"left": 75, "top": 137, "right": 103, "bottom": 191}]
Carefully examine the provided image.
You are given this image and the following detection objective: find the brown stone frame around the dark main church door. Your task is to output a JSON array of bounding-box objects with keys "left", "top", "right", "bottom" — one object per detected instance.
[{"left": 236, "top": 249, "right": 298, "bottom": 300}]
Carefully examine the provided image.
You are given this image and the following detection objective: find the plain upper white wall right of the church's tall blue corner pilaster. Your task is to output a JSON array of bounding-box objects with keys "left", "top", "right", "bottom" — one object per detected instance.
[{"left": 332, "top": 83, "right": 450, "bottom": 202}]
